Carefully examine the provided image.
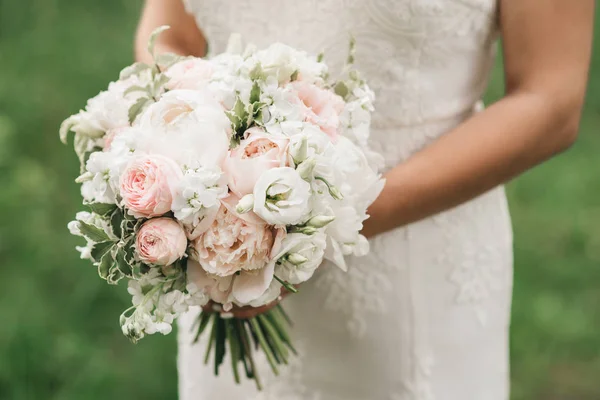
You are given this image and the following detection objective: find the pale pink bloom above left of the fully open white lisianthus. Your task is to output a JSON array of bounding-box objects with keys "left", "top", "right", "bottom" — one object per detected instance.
[{"left": 223, "top": 128, "right": 289, "bottom": 197}]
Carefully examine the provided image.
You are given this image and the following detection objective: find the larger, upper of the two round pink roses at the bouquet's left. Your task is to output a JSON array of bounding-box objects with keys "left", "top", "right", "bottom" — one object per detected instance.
[{"left": 120, "top": 155, "right": 182, "bottom": 218}]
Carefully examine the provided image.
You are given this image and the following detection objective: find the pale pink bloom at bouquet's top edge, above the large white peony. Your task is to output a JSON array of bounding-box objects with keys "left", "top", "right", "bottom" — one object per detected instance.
[{"left": 166, "top": 58, "right": 213, "bottom": 90}]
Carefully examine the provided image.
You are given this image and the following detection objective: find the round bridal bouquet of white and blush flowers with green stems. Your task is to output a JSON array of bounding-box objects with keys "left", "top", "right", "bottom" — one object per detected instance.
[{"left": 61, "top": 27, "right": 383, "bottom": 387}]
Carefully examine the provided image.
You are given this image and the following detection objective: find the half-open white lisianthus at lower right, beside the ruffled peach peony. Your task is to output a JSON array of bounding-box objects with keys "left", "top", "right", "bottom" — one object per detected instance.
[{"left": 275, "top": 232, "right": 326, "bottom": 285}]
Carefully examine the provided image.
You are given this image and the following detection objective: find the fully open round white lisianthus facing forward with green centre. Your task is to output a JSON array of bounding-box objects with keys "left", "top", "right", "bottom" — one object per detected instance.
[{"left": 254, "top": 167, "right": 311, "bottom": 225}]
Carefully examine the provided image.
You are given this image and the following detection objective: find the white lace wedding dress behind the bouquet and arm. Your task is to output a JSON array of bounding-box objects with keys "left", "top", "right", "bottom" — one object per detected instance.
[{"left": 178, "top": 0, "right": 512, "bottom": 400}]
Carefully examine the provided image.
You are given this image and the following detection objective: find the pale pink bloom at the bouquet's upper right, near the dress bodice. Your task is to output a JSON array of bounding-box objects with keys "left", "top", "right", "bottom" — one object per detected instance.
[{"left": 290, "top": 81, "right": 345, "bottom": 142}]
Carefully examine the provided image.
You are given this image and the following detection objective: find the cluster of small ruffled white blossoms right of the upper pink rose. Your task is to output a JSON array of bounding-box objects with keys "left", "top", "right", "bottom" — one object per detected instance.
[{"left": 172, "top": 166, "right": 228, "bottom": 227}]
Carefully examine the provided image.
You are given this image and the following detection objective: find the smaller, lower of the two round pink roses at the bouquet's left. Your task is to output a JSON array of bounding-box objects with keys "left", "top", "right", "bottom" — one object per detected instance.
[{"left": 135, "top": 218, "right": 187, "bottom": 265}]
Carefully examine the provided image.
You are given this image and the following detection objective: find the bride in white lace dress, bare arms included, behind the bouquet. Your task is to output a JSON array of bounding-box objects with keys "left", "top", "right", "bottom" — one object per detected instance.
[{"left": 137, "top": 0, "right": 594, "bottom": 400}]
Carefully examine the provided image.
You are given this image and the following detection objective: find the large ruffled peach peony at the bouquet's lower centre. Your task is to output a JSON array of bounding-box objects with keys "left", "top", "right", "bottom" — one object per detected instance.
[{"left": 193, "top": 195, "right": 275, "bottom": 276}]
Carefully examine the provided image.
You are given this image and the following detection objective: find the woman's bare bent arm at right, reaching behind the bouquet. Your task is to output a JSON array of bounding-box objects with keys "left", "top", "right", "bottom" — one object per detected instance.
[{"left": 363, "top": 0, "right": 594, "bottom": 237}]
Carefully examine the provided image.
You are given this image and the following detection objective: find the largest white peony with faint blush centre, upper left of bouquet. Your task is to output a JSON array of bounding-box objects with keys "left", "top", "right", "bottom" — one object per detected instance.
[{"left": 137, "top": 90, "right": 231, "bottom": 166}]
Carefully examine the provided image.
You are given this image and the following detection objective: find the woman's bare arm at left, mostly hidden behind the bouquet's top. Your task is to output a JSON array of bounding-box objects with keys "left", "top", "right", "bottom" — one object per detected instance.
[{"left": 135, "top": 0, "right": 206, "bottom": 62}]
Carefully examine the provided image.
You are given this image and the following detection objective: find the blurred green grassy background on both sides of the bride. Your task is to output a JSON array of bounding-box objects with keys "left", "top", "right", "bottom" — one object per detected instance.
[{"left": 0, "top": 0, "right": 600, "bottom": 400}]
